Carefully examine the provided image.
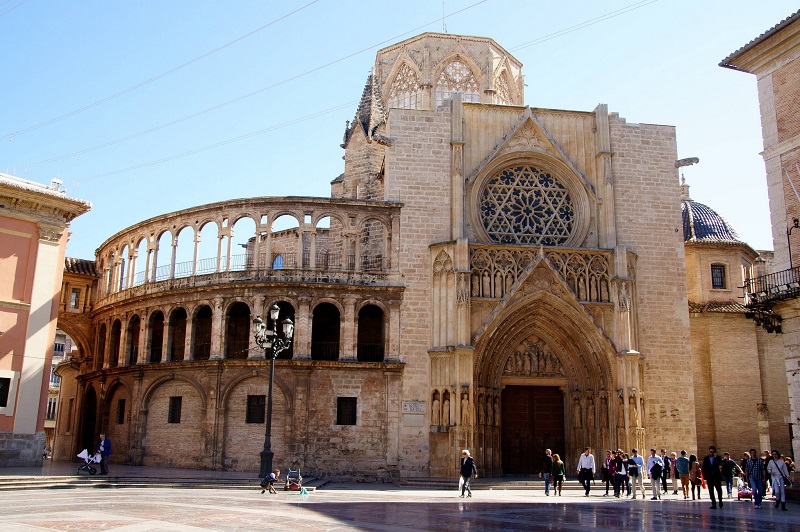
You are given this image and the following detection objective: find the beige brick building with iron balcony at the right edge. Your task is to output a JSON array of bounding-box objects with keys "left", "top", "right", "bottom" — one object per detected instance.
[{"left": 720, "top": 11, "right": 800, "bottom": 456}]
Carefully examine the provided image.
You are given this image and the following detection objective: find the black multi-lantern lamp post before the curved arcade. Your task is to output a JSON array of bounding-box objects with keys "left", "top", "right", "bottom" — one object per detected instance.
[{"left": 253, "top": 303, "right": 294, "bottom": 478}]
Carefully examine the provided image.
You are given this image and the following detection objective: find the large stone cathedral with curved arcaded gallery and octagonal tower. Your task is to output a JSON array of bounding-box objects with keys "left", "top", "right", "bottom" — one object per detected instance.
[{"left": 54, "top": 33, "right": 788, "bottom": 480}]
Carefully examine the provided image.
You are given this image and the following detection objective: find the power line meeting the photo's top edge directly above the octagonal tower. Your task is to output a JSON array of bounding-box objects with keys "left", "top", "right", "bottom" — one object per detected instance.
[{"left": 21, "top": 0, "right": 488, "bottom": 168}]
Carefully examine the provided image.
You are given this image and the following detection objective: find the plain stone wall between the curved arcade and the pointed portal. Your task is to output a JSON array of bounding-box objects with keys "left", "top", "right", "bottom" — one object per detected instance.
[{"left": 385, "top": 109, "right": 451, "bottom": 476}]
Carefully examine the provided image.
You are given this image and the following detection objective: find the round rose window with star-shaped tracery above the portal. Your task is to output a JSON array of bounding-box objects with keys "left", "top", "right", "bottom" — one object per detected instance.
[{"left": 480, "top": 165, "right": 575, "bottom": 246}]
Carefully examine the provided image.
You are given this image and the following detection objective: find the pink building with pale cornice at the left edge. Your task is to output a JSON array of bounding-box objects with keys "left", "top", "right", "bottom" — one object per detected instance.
[{"left": 0, "top": 173, "right": 91, "bottom": 466}]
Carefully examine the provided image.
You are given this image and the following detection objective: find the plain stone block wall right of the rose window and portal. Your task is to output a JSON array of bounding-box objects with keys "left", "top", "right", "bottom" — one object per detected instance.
[{"left": 609, "top": 114, "right": 696, "bottom": 450}]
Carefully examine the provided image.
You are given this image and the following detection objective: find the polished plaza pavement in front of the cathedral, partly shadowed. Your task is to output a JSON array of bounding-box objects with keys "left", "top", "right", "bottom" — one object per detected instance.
[{"left": 0, "top": 464, "right": 800, "bottom": 532}]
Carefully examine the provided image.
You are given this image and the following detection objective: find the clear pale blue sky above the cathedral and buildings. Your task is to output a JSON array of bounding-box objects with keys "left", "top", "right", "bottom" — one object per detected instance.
[{"left": 0, "top": 0, "right": 798, "bottom": 259}]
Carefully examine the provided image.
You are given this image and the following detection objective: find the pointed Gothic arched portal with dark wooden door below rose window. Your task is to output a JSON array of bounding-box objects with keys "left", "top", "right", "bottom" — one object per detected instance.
[{"left": 473, "top": 265, "right": 617, "bottom": 476}]
